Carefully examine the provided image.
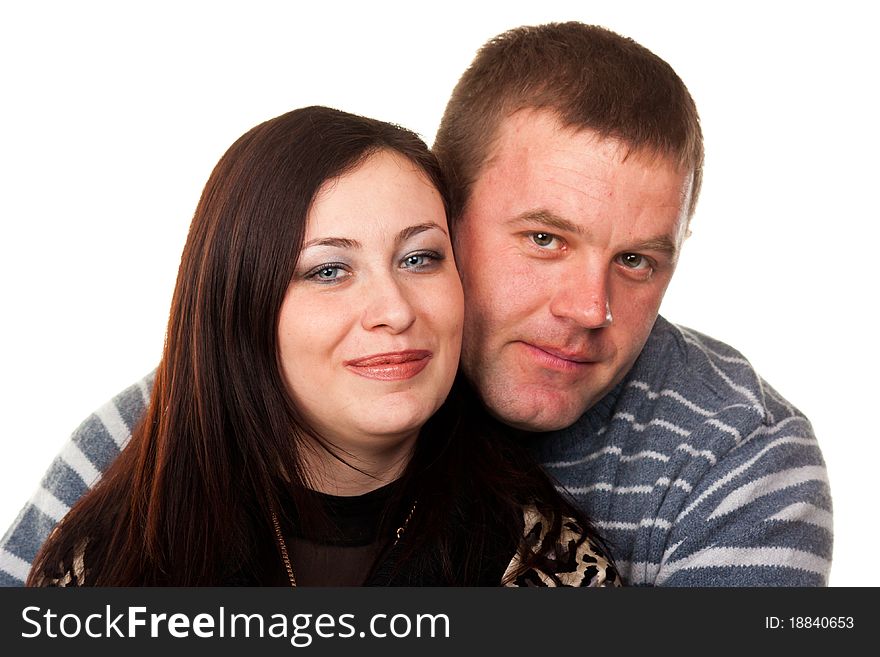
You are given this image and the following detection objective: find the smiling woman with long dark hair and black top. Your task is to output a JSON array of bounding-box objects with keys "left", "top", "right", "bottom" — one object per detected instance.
[{"left": 28, "top": 107, "right": 617, "bottom": 586}]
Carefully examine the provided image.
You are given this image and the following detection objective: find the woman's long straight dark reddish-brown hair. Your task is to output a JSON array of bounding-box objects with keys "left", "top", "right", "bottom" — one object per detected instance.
[{"left": 28, "top": 107, "right": 600, "bottom": 586}]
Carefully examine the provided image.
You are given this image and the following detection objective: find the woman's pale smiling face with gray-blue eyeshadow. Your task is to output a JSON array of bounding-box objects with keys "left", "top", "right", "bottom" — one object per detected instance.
[{"left": 278, "top": 151, "right": 464, "bottom": 460}]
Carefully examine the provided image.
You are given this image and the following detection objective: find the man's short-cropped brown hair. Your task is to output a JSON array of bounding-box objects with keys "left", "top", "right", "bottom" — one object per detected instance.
[{"left": 433, "top": 22, "right": 703, "bottom": 220}]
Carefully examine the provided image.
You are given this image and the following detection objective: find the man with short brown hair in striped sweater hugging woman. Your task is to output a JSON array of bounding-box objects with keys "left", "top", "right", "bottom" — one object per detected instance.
[{"left": 0, "top": 23, "right": 832, "bottom": 586}]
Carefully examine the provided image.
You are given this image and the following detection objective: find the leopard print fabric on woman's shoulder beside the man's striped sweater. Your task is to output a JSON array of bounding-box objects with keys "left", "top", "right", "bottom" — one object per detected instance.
[{"left": 502, "top": 505, "right": 621, "bottom": 586}]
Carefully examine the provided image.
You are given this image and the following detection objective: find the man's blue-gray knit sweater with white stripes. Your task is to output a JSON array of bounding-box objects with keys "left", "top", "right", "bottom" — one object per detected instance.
[{"left": 0, "top": 318, "right": 832, "bottom": 586}]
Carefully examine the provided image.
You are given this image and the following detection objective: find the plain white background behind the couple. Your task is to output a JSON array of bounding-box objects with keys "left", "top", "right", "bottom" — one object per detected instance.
[{"left": 0, "top": 0, "right": 880, "bottom": 586}]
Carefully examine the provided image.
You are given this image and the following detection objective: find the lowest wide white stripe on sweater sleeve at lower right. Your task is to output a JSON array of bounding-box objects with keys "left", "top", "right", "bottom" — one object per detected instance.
[{"left": 656, "top": 547, "right": 831, "bottom": 585}]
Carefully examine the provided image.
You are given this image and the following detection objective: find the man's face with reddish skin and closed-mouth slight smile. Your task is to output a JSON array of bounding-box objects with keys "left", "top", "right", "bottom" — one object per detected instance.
[{"left": 455, "top": 110, "right": 692, "bottom": 431}]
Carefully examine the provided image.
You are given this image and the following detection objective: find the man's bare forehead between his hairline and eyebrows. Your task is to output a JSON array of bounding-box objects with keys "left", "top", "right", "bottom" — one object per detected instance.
[{"left": 466, "top": 110, "right": 693, "bottom": 251}]
